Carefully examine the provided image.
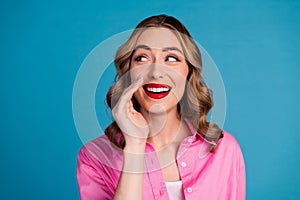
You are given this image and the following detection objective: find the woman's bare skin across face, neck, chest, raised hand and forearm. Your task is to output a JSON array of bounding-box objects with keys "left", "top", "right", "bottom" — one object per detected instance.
[{"left": 112, "top": 28, "right": 191, "bottom": 199}]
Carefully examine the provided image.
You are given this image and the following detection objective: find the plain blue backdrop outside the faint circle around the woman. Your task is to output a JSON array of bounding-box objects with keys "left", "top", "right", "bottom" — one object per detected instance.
[{"left": 0, "top": 0, "right": 300, "bottom": 199}]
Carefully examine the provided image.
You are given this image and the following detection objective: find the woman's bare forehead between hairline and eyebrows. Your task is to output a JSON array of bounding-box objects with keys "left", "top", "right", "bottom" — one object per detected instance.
[{"left": 135, "top": 27, "right": 182, "bottom": 50}]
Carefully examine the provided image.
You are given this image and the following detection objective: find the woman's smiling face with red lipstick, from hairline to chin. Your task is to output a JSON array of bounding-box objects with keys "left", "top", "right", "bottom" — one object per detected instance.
[{"left": 130, "top": 28, "right": 189, "bottom": 113}]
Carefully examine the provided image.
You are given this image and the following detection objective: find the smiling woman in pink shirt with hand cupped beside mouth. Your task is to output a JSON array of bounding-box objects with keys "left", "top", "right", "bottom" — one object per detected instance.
[{"left": 77, "top": 15, "right": 245, "bottom": 200}]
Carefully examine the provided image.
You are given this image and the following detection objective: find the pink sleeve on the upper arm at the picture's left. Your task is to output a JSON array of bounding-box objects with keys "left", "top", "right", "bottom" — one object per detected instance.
[{"left": 76, "top": 147, "right": 113, "bottom": 200}]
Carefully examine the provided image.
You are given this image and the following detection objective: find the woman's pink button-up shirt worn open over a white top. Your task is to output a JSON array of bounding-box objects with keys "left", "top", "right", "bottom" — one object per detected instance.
[{"left": 77, "top": 123, "right": 246, "bottom": 200}]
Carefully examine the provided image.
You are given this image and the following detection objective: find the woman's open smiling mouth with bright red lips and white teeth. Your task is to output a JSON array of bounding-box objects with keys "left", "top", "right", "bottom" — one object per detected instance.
[{"left": 143, "top": 83, "right": 171, "bottom": 99}]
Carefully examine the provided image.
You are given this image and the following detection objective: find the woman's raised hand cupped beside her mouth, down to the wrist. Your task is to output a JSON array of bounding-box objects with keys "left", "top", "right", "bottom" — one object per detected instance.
[{"left": 112, "top": 77, "right": 149, "bottom": 146}]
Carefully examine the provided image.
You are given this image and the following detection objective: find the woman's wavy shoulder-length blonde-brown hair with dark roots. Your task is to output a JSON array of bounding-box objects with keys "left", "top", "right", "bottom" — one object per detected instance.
[{"left": 105, "top": 15, "right": 223, "bottom": 152}]
